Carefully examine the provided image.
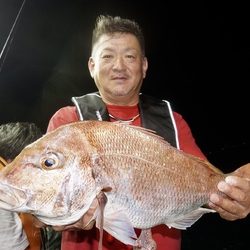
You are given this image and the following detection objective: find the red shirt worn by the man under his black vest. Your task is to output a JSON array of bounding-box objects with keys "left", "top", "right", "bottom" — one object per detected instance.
[{"left": 47, "top": 106, "right": 205, "bottom": 250}]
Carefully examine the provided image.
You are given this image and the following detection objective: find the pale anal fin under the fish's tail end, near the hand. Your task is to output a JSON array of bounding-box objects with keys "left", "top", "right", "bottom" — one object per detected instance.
[{"left": 166, "top": 208, "right": 215, "bottom": 230}]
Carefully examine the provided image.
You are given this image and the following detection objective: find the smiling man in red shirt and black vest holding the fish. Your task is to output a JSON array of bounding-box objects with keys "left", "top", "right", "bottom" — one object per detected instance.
[{"left": 45, "top": 16, "right": 250, "bottom": 250}]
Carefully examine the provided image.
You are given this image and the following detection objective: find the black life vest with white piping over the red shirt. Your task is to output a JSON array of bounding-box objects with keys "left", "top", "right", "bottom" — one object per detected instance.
[{"left": 72, "top": 92, "right": 179, "bottom": 148}]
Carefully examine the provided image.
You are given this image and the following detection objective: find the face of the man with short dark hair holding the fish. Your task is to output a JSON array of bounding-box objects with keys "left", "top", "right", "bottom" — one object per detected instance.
[{"left": 88, "top": 33, "right": 148, "bottom": 104}]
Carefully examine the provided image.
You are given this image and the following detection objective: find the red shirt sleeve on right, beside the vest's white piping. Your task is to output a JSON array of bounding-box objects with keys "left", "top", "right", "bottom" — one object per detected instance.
[{"left": 174, "top": 112, "right": 206, "bottom": 159}]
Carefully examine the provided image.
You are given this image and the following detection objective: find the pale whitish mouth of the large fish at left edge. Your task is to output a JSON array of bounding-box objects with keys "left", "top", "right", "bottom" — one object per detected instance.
[{"left": 0, "top": 182, "right": 28, "bottom": 212}]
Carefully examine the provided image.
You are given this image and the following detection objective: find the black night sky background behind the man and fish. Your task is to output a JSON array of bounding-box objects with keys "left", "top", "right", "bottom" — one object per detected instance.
[{"left": 0, "top": 0, "right": 250, "bottom": 250}]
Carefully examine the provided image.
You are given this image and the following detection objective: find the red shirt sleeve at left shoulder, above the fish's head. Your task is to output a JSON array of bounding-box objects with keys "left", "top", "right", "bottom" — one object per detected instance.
[{"left": 47, "top": 106, "right": 79, "bottom": 132}]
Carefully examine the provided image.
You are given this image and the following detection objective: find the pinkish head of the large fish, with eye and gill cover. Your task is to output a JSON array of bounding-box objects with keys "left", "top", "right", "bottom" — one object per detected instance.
[{"left": 0, "top": 128, "right": 96, "bottom": 225}]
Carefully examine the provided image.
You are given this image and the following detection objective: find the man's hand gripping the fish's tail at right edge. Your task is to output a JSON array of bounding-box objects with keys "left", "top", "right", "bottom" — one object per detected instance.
[{"left": 209, "top": 163, "right": 250, "bottom": 221}]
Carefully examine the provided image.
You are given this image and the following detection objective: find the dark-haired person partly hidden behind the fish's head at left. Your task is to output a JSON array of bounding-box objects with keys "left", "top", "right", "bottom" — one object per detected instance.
[{"left": 0, "top": 122, "right": 42, "bottom": 250}]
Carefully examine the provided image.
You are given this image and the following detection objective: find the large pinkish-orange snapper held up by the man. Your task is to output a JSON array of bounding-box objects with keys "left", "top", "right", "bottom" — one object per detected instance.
[{"left": 0, "top": 121, "right": 225, "bottom": 245}]
